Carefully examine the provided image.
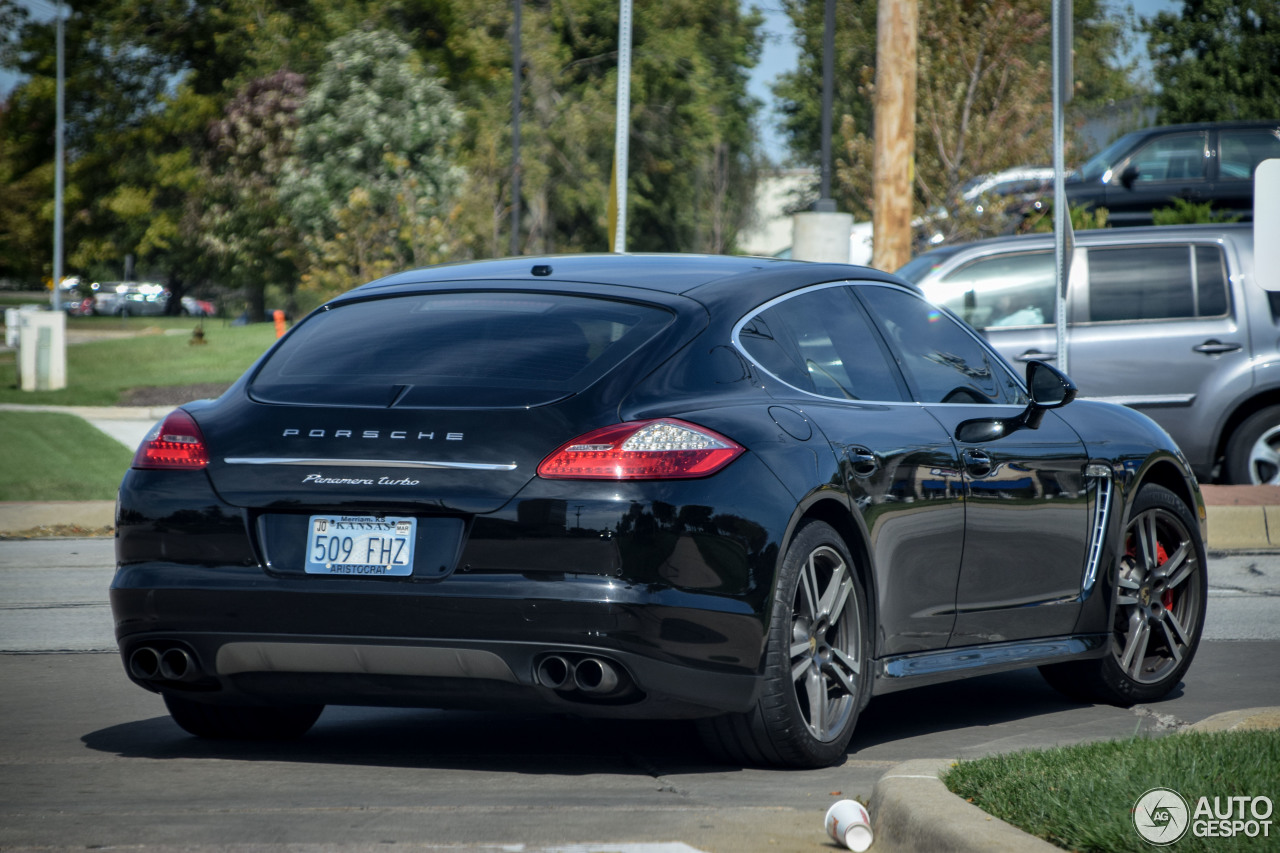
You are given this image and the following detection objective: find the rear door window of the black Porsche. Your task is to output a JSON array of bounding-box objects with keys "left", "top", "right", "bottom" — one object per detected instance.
[{"left": 737, "top": 287, "right": 904, "bottom": 402}]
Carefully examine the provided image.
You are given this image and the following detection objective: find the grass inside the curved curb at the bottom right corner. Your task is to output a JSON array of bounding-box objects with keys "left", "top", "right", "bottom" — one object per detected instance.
[{"left": 943, "top": 731, "right": 1280, "bottom": 853}]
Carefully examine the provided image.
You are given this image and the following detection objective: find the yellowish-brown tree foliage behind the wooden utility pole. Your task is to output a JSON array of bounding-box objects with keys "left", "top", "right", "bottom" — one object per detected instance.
[{"left": 774, "top": 0, "right": 1133, "bottom": 238}]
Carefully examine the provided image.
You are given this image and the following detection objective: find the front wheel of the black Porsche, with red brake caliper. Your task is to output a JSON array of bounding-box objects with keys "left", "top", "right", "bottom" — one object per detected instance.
[{"left": 1041, "top": 484, "right": 1208, "bottom": 707}]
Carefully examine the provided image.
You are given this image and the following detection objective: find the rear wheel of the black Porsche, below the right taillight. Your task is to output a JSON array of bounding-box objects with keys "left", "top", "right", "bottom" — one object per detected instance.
[{"left": 699, "top": 521, "right": 872, "bottom": 767}]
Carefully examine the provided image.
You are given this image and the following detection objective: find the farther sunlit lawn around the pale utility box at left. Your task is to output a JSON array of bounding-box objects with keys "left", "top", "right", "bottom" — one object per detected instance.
[{"left": 0, "top": 318, "right": 275, "bottom": 406}]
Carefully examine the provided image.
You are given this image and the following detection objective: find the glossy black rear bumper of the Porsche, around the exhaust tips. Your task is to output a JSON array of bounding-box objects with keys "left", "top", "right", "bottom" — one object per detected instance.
[{"left": 111, "top": 564, "right": 763, "bottom": 719}]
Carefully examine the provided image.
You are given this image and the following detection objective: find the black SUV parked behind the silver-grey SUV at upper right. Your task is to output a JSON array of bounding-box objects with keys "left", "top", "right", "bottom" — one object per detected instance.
[{"left": 1066, "top": 119, "right": 1280, "bottom": 225}]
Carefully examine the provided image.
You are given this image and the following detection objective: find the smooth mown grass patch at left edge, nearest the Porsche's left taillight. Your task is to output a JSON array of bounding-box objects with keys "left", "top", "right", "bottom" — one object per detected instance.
[{"left": 0, "top": 411, "right": 133, "bottom": 501}]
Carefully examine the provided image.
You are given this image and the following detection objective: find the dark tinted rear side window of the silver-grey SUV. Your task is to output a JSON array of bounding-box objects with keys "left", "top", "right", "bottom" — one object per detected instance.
[{"left": 1088, "top": 246, "right": 1228, "bottom": 323}]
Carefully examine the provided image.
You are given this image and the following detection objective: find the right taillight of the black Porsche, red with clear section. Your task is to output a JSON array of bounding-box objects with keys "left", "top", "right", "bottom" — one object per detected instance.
[{"left": 538, "top": 418, "right": 744, "bottom": 480}]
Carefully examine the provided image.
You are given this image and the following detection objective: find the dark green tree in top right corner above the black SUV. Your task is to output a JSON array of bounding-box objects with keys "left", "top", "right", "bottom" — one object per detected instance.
[{"left": 1143, "top": 0, "right": 1280, "bottom": 123}]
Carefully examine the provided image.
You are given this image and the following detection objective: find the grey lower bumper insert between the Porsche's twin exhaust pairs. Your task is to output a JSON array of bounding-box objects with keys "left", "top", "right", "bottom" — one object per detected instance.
[{"left": 214, "top": 642, "right": 520, "bottom": 684}]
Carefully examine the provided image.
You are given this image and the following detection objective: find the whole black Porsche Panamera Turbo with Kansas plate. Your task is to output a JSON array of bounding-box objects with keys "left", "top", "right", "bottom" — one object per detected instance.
[{"left": 111, "top": 255, "right": 1206, "bottom": 766}]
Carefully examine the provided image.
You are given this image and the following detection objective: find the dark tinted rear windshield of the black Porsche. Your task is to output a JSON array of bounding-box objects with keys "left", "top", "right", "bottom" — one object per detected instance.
[{"left": 250, "top": 292, "right": 672, "bottom": 407}]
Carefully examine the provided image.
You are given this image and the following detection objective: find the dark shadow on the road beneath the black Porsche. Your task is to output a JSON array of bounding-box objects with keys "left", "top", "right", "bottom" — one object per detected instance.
[{"left": 82, "top": 670, "right": 1180, "bottom": 776}]
